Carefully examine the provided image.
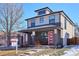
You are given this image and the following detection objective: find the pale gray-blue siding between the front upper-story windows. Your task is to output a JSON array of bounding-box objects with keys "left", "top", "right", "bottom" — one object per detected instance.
[{"left": 27, "top": 13, "right": 59, "bottom": 27}]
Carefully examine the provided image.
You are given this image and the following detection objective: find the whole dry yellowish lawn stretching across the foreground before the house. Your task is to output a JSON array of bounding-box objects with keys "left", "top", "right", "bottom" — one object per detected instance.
[{"left": 0, "top": 48, "right": 68, "bottom": 56}]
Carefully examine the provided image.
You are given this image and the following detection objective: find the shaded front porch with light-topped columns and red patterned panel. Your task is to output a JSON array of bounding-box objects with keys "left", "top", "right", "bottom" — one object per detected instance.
[{"left": 21, "top": 27, "right": 62, "bottom": 46}]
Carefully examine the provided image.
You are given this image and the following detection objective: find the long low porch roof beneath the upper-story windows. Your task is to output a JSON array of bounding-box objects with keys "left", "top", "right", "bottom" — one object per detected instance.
[{"left": 19, "top": 25, "right": 62, "bottom": 33}]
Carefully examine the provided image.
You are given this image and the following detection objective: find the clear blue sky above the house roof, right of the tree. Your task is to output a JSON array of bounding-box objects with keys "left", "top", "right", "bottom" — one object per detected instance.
[{"left": 22, "top": 3, "right": 79, "bottom": 27}]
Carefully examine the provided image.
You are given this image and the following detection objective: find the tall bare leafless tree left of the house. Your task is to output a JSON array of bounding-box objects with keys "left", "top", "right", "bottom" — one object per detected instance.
[{"left": 0, "top": 3, "right": 23, "bottom": 46}]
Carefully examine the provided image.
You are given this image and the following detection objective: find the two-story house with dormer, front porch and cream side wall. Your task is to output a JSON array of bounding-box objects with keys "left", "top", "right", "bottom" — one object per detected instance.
[{"left": 20, "top": 7, "right": 75, "bottom": 46}]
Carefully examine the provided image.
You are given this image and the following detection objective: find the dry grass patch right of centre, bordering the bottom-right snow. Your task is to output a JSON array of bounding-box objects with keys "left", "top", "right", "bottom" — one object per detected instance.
[{"left": 32, "top": 48, "right": 68, "bottom": 56}]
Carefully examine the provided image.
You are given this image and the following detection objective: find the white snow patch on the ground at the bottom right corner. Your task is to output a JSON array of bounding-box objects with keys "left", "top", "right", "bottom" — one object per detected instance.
[{"left": 62, "top": 45, "right": 79, "bottom": 56}]
